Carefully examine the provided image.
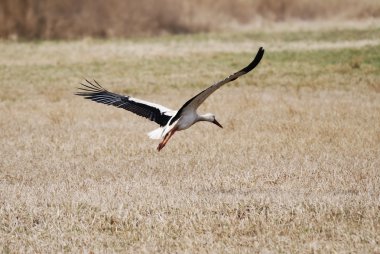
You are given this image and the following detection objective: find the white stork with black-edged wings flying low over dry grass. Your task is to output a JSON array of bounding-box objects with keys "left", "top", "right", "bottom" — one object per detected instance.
[{"left": 75, "top": 47, "right": 264, "bottom": 151}]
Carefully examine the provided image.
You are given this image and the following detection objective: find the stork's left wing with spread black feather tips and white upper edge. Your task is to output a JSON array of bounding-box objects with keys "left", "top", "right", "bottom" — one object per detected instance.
[{"left": 75, "top": 80, "right": 176, "bottom": 126}]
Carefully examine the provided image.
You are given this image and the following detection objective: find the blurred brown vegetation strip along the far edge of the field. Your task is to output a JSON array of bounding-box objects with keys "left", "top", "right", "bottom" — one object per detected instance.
[{"left": 0, "top": 0, "right": 380, "bottom": 39}]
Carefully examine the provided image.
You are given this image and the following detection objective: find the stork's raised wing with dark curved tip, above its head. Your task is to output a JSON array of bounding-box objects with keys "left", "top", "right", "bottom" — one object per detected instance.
[{"left": 170, "top": 47, "right": 264, "bottom": 124}]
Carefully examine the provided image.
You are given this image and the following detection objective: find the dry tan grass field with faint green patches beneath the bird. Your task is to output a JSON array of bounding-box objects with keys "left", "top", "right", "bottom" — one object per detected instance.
[{"left": 0, "top": 20, "right": 380, "bottom": 253}]
